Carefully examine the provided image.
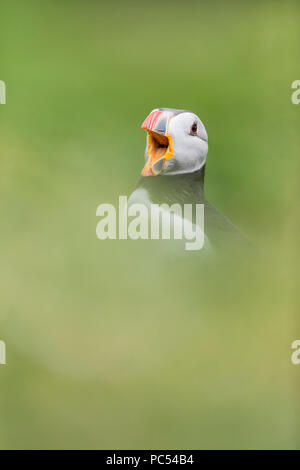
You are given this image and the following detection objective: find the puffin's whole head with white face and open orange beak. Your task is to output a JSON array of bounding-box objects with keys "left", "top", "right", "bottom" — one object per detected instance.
[{"left": 142, "top": 108, "right": 208, "bottom": 176}]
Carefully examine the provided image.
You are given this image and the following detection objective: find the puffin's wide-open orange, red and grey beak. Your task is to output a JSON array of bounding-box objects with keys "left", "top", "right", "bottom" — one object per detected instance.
[{"left": 142, "top": 110, "right": 174, "bottom": 176}]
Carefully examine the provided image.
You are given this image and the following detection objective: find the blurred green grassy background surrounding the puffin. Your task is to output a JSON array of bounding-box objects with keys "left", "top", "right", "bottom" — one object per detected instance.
[{"left": 0, "top": 0, "right": 300, "bottom": 449}]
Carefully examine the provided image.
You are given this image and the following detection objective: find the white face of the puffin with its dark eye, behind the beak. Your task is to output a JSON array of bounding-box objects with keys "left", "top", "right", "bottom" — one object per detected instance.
[{"left": 142, "top": 112, "right": 208, "bottom": 176}]
